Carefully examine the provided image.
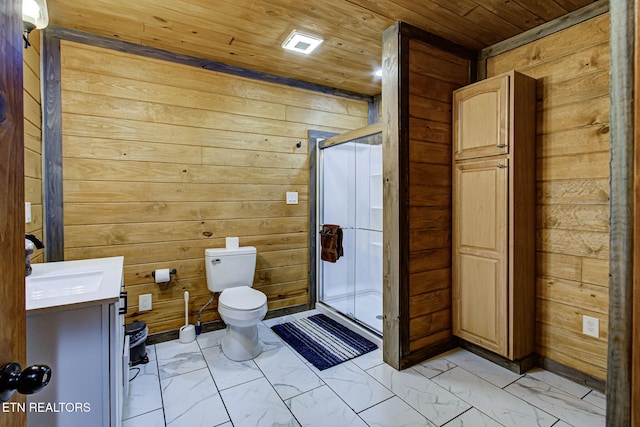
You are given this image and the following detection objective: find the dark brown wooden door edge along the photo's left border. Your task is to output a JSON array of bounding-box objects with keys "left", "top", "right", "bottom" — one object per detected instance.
[{"left": 0, "top": 0, "right": 27, "bottom": 427}]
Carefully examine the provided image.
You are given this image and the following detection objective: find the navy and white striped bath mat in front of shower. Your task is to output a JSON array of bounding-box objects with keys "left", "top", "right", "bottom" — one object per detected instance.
[{"left": 271, "top": 314, "right": 378, "bottom": 371}]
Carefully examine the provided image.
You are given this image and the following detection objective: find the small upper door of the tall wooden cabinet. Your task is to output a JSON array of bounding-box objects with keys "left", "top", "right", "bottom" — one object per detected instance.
[{"left": 453, "top": 75, "right": 511, "bottom": 160}]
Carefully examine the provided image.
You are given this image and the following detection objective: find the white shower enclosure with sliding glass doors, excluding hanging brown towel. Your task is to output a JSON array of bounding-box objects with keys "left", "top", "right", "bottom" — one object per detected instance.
[{"left": 316, "top": 126, "right": 382, "bottom": 335}]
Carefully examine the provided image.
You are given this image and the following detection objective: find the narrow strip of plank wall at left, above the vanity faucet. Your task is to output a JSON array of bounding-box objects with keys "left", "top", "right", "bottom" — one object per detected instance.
[{"left": 23, "top": 30, "right": 46, "bottom": 262}]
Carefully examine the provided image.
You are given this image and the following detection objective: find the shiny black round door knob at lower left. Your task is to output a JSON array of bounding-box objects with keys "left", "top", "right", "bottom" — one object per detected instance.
[{"left": 0, "top": 363, "right": 51, "bottom": 402}]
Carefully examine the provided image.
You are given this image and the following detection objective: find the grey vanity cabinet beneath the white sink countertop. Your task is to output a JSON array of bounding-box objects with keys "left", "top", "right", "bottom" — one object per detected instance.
[{"left": 27, "top": 257, "right": 129, "bottom": 427}]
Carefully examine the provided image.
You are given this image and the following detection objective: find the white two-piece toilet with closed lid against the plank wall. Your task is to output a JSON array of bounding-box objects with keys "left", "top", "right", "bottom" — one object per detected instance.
[{"left": 204, "top": 246, "right": 267, "bottom": 361}]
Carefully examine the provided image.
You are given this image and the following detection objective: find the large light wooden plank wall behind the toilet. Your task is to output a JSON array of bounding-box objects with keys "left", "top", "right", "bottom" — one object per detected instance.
[{"left": 61, "top": 41, "right": 368, "bottom": 333}]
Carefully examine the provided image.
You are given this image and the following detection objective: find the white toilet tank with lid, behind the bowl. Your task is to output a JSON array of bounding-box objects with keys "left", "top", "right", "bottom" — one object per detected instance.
[{"left": 204, "top": 246, "right": 257, "bottom": 292}]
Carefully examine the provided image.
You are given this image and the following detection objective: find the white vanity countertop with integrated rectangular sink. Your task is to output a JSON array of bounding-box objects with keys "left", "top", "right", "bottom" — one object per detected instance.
[{"left": 25, "top": 256, "right": 124, "bottom": 314}]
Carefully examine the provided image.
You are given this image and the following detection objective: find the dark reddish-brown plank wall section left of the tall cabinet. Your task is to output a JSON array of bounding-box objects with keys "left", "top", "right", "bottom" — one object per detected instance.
[{"left": 408, "top": 39, "right": 470, "bottom": 352}]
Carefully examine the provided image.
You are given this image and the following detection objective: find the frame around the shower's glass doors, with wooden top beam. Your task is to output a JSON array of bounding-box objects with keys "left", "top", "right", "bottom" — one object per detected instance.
[{"left": 309, "top": 123, "right": 382, "bottom": 337}]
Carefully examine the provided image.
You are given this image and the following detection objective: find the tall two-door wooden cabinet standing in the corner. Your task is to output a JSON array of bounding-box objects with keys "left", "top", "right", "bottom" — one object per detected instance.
[{"left": 452, "top": 71, "right": 536, "bottom": 360}]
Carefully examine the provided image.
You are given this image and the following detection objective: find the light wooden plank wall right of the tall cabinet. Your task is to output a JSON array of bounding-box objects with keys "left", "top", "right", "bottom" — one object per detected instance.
[{"left": 487, "top": 14, "right": 610, "bottom": 379}]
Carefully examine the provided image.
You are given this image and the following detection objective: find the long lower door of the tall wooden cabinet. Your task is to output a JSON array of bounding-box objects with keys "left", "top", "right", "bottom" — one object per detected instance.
[{"left": 453, "top": 157, "right": 509, "bottom": 356}]
